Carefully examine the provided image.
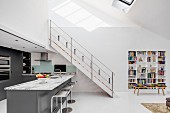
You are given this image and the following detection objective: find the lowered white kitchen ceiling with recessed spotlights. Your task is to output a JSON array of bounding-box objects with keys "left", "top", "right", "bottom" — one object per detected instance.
[{"left": 0, "top": 30, "right": 46, "bottom": 52}]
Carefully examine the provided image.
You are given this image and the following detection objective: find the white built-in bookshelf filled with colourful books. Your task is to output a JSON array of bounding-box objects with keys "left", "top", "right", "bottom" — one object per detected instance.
[{"left": 128, "top": 51, "right": 166, "bottom": 89}]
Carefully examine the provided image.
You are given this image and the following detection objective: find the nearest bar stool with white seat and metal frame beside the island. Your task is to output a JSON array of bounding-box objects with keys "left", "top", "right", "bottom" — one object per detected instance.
[{"left": 51, "top": 89, "right": 71, "bottom": 113}]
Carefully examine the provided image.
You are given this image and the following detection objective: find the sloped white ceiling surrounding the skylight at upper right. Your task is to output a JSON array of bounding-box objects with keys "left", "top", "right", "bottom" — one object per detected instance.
[{"left": 67, "top": 0, "right": 170, "bottom": 40}]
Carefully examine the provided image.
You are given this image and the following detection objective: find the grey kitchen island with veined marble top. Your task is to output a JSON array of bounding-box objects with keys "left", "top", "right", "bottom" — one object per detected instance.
[{"left": 5, "top": 75, "right": 74, "bottom": 113}]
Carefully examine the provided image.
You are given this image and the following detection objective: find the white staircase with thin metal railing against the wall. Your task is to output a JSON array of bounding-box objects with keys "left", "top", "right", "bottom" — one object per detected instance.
[{"left": 49, "top": 20, "right": 115, "bottom": 97}]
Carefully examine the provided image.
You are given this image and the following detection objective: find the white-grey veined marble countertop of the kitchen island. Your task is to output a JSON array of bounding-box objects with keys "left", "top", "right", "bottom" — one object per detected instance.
[{"left": 4, "top": 75, "right": 74, "bottom": 90}]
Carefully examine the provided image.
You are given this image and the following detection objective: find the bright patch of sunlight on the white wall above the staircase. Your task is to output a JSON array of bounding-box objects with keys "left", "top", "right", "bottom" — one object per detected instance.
[{"left": 52, "top": 0, "right": 111, "bottom": 32}]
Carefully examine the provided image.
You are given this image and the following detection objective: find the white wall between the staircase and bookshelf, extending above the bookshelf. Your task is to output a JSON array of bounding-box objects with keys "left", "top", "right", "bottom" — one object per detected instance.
[{"left": 59, "top": 28, "right": 170, "bottom": 91}]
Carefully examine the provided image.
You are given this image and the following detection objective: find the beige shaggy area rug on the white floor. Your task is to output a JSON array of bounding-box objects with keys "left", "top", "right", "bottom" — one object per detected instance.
[{"left": 141, "top": 103, "right": 170, "bottom": 113}]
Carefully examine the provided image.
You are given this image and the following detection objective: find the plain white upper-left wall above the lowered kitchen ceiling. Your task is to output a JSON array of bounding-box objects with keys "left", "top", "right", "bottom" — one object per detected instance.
[{"left": 0, "top": 0, "right": 49, "bottom": 46}]
